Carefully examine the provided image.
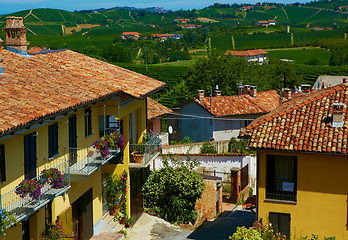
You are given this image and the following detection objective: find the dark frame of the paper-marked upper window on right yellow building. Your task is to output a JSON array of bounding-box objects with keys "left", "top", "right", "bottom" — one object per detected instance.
[{"left": 266, "top": 155, "right": 298, "bottom": 203}]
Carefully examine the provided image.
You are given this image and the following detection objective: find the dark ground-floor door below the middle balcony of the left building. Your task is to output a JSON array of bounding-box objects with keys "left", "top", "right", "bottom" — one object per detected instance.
[{"left": 72, "top": 188, "right": 93, "bottom": 240}]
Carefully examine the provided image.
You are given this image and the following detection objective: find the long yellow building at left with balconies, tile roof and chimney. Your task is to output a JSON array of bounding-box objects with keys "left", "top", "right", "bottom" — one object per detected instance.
[{"left": 0, "top": 17, "right": 165, "bottom": 240}]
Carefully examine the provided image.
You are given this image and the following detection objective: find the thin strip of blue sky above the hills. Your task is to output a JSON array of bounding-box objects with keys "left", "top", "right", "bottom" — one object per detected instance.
[{"left": 0, "top": 0, "right": 303, "bottom": 14}]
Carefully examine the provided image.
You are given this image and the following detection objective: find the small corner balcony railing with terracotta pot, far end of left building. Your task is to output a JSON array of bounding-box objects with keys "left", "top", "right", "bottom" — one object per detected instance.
[{"left": 129, "top": 134, "right": 162, "bottom": 166}]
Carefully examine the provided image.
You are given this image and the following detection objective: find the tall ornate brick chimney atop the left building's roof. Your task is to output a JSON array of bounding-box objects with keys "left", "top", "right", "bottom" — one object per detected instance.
[{"left": 5, "top": 17, "right": 27, "bottom": 55}]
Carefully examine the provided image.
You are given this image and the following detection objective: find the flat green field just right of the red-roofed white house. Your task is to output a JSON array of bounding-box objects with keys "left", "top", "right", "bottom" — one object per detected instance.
[{"left": 266, "top": 48, "right": 330, "bottom": 65}]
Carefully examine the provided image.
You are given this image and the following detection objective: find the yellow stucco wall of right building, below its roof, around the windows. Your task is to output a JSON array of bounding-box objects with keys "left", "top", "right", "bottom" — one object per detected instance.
[{"left": 258, "top": 151, "right": 348, "bottom": 239}]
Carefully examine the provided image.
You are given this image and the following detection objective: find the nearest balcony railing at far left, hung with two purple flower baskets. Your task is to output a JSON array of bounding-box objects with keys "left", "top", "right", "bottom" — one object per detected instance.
[{"left": 1, "top": 158, "right": 70, "bottom": 221}]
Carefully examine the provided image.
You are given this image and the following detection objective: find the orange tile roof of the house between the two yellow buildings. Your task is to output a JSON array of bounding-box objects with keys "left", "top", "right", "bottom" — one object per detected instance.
[{"left": 194, "top": 90, "right": 279, "bottom": 116}]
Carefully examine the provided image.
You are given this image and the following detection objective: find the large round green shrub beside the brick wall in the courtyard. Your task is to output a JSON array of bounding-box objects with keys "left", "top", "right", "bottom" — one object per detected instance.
[{"left": 143, "top": 154, "right": 204, "bottom": 224}]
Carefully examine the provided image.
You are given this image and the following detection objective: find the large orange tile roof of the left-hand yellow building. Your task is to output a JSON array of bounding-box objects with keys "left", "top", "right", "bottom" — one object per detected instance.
[{"left": 0, "top": 50, "right": 165, "bottom": 134}]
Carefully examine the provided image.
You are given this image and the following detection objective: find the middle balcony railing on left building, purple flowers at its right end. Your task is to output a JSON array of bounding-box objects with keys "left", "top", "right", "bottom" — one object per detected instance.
[{"left": 69, "top": 147, "right": 120, "bottom": 176}]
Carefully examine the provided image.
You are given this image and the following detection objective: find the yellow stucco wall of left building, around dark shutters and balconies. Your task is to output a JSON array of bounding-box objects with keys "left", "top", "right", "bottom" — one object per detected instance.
[{"left": 0, "top": 95, "right": 146, "bottom": 239}]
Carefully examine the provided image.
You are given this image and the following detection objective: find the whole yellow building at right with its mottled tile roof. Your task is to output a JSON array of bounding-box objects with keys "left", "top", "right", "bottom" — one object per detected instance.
[{"left": 244, "top": 83, "right": 348, "bottom": 240}]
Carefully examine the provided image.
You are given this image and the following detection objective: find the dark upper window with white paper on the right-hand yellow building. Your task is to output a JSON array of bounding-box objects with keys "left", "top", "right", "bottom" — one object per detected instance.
[{"left": 266, "top": 155, "right": 297, "bottom": 201}]
